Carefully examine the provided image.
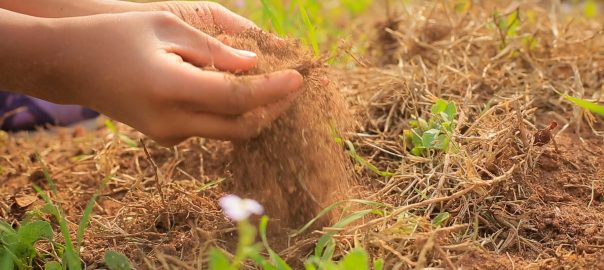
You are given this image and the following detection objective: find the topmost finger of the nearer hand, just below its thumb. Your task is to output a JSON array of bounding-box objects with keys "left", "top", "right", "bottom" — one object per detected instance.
[{"left": 166, "top": 65, "right": 303, "bottom": 115}]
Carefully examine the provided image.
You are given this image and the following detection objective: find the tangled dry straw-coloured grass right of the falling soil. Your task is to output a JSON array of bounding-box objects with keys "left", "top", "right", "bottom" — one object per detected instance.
[{"left": 304, "top": 3, "right": 604, "bottom": 269}]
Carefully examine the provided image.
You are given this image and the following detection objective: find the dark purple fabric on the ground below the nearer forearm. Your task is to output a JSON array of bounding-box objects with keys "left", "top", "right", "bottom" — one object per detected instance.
[{"left": 0, "top": 91, "right": 99, "bottom": 131}]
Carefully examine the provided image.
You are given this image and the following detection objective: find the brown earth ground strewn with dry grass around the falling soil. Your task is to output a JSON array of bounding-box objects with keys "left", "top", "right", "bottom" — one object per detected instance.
[{"left": 0, "top": 2, "right": 604, "bottom": 269}]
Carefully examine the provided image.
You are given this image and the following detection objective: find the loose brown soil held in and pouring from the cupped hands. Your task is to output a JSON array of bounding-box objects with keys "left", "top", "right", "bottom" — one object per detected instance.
[{"left": 219, "top": 31, "right": 353, "bottom": 227}]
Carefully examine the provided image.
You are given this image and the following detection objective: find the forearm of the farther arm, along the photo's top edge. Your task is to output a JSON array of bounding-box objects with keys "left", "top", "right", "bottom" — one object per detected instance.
[{"left": 0, "top": 0, "right": 142, "bottom": 18}]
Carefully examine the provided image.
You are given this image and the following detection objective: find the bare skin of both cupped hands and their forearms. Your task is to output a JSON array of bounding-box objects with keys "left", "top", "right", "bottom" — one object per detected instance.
[{"left": 0, "top": 0, "right": 303, "bottom": 146}]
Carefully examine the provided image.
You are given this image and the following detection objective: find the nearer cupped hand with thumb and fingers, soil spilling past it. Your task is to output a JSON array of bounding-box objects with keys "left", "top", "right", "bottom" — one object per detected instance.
[{"left": 30, "top": 12, "right": 303, "bottom": 145}]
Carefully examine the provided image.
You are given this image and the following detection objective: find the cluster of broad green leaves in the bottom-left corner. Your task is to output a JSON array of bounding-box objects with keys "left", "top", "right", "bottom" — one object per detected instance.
[{"left": 0, "top": 221, "right": 53, "bottom": 269}]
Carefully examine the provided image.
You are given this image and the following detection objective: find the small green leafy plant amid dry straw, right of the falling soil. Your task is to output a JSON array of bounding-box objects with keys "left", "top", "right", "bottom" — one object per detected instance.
[{"left": 403, "top": 99, "right": 457, "bottom": 156}]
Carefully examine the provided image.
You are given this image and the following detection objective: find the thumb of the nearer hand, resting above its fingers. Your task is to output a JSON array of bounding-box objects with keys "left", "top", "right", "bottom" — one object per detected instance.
[{"left": 171, "top": 25, "right": 258, "bottom": 72}]
